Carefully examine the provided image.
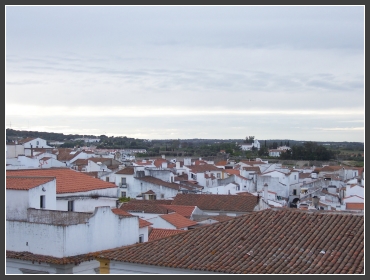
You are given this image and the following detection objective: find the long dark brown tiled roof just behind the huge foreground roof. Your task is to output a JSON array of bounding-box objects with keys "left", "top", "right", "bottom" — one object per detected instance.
[{"left": 172, "top": 194, "right": 257, "bottom": 212}]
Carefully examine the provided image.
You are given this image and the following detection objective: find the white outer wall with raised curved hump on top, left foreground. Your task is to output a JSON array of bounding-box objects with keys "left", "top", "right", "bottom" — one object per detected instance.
[{"left": 6, "top": 207, "right": 139, "bottom": 258}]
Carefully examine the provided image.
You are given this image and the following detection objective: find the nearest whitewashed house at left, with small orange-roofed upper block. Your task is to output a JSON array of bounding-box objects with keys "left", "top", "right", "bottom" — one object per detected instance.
[{"left": 6, "top": 174, "right": 144, "bottom": 274}]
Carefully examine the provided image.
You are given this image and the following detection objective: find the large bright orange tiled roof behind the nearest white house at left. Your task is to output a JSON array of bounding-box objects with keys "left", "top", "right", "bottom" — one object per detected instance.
[{"left": 6, "top": 168, "right": 117, "bottom": 194}]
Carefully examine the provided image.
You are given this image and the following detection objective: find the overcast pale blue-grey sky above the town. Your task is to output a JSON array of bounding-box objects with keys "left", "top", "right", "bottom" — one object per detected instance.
[{"left": 5, "top": 6, "right": 365, "bottom": 142}]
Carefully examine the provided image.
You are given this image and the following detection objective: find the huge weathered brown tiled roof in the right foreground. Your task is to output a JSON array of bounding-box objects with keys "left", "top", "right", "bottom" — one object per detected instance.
[{"left": 98, "top": 209, "right": 364, "bottom": 274}]
